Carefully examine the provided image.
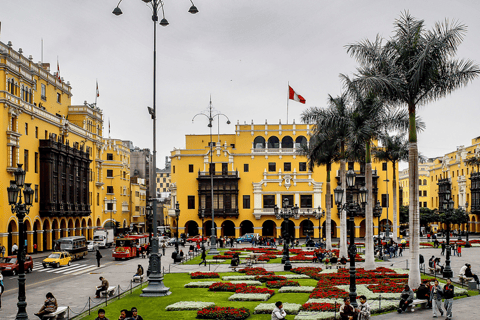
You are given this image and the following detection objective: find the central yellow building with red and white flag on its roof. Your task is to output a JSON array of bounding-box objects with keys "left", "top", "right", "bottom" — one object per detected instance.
[{"left": 169, "top": 123, "right": 398, "bottom": 238}]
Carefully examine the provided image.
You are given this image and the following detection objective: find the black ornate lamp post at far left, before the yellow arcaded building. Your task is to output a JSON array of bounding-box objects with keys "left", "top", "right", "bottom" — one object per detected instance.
[{"left": 7, "top": 164, "right": 35, "bottom": 319}]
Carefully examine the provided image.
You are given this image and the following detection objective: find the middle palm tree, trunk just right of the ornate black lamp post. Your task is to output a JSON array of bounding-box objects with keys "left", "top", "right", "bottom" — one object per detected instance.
[{"left": 341, "top": 75, "right": 408, "bottom": 270}]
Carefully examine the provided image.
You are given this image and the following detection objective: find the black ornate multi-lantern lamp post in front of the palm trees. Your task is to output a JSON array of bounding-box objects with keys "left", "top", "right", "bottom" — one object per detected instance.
[{"left": 333, "top": 170, "right": 368, "bottom": 308}]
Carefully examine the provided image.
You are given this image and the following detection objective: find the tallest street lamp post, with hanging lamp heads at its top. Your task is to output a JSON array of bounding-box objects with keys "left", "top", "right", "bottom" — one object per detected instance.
[{"left": 112, "top": 0, "right": 198, "bottom": 297}]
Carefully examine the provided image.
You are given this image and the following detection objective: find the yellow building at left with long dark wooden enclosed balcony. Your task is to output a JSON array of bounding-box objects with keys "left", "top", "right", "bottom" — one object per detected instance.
[{"left": 0, "top": 42, "right": 137, "bottom": 252}]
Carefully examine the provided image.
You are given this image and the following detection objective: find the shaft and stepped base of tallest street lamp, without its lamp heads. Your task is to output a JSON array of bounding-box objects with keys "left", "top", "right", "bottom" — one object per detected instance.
[{"left": 140, "top": 0, "right": 171, "bottom": 297}]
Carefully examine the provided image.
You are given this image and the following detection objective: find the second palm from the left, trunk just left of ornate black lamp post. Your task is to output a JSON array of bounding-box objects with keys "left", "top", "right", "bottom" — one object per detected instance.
[{"left": 302, "top": 93, "right": 352, "bottom": 257}]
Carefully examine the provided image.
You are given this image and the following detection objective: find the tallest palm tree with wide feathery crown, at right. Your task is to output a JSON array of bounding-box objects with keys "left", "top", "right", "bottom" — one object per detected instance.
[{"left": 347, "top": 12, "right": 480, "bottom": 288}]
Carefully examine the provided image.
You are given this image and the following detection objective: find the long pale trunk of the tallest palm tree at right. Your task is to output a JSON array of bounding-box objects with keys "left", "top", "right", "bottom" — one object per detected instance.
[{"left": 408, "top": 104, "right": 421, "bottom": 288}]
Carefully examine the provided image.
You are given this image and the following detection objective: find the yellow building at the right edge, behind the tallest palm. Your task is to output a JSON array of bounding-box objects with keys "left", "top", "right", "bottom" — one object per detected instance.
[{"left": 400, "top": 137, "right": 480, "bottom": 232}]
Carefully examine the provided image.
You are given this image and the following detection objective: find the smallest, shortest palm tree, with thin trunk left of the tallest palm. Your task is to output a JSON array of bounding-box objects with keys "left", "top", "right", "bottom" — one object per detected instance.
[{"left": 372, "top": 133, "right": 408, "bottom": 242}]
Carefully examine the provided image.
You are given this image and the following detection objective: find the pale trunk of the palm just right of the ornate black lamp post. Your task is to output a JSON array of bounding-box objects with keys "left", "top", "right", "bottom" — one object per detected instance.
[{"left": 363, "top": 141, "right": 376, "bottom": 270}]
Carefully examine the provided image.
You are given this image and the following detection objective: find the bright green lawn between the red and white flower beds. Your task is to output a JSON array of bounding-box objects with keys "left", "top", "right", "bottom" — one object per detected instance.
[{"left": 78, "top": 272, "right": 310, "bottom": 320}]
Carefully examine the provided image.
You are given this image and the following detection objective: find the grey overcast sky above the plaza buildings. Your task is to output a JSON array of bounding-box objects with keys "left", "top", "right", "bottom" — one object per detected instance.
[{"left": 0, "top": 0, "right": 480, "bottom": 168}]
